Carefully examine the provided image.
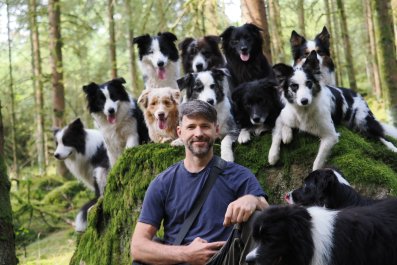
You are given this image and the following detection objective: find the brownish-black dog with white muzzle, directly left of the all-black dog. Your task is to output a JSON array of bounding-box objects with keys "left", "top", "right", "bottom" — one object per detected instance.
[{"left": 178, "top": 35, "right": 226, "bottom": 74}]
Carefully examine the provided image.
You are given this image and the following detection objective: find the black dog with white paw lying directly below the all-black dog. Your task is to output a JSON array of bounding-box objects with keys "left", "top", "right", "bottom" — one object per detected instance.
[{"left": 232, "top": 78, "right": 282, "bottom": 144}]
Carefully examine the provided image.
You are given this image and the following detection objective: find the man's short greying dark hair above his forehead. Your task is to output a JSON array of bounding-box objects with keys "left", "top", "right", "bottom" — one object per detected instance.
[{"left": 179, "top": 99, "right": 217, "bottom": 123}]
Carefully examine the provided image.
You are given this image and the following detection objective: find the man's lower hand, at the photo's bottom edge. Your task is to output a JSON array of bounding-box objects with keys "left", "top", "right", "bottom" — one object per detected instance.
[{"left": 185, "top": 237, "right": 225, "bottom": 265}]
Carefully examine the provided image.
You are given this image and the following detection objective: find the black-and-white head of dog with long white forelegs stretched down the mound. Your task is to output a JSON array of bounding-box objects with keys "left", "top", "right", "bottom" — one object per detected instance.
[{"left": 273, "top": 51, "right": 322, "bottom": 107}]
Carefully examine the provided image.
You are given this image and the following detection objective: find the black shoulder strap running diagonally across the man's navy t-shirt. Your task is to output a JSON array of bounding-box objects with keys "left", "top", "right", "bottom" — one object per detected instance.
[{"left": 174, "top": 156, "right": 226, "bottom": 245}]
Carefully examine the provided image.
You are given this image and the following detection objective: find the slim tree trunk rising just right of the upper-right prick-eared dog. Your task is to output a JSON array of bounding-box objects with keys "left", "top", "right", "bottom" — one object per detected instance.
[{"left": 336, "top": 0, "right": 357, "bottom": 91}]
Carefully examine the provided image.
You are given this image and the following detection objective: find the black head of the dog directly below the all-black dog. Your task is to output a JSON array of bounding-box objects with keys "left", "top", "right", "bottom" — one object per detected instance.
[{"left": 232, "top": 78, "right": 281, "bottom": 125}]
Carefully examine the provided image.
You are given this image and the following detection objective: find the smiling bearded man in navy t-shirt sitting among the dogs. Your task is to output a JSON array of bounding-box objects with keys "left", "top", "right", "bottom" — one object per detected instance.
[{"left": 131, "top": 100, "right": 268, "bottom": 264}]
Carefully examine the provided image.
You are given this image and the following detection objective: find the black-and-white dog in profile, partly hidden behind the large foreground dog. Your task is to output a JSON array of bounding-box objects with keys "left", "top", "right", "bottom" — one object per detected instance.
[{"left": 285, "top": 168, "right": 381, "bottom": 209}]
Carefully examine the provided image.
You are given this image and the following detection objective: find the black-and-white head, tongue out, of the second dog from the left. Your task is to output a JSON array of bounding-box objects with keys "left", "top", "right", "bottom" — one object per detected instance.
[{"left": 83, "top": 77, "right": 130, "bottom": 124}]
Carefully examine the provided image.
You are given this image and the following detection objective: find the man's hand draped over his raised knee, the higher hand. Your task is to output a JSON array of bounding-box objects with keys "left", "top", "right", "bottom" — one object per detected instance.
[{"left": 223, "top": 195, "right": 269, "bottom": 226}]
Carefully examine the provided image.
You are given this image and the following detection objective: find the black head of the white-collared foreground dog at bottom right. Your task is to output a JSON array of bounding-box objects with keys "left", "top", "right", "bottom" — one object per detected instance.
[{"left": 246, "top": 206, "right": 313, "bottom": 265}]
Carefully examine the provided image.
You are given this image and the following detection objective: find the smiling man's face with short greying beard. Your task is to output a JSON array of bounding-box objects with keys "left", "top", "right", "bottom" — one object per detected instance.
[{"left": 177, "top": 116, "right": 219, "bottom": 157}]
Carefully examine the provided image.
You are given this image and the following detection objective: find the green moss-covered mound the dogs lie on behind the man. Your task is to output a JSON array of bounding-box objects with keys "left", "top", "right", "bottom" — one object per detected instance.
[{"left": 71, "top": 128, "right": 397, "bottom": 265}]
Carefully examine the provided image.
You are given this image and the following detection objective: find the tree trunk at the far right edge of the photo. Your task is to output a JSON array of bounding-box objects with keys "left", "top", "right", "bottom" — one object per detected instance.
[{"left": 375, "top": 0, "right": 397, "bottom": 126}]
